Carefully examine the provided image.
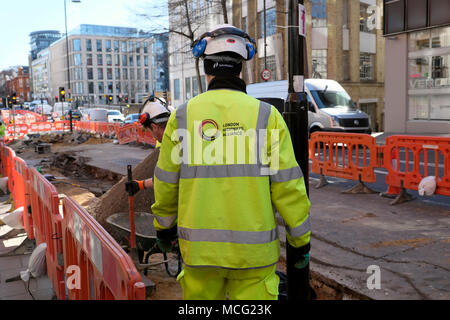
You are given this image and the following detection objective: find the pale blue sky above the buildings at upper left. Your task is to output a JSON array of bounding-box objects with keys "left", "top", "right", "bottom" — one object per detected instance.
[{"left": 0, "top": 0, "right": 167, "bottom": 71}]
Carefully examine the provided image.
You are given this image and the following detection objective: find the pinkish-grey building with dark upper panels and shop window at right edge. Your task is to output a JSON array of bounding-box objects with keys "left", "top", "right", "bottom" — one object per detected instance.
[{"left": 384, "top": 0, "right": 450, "bottom": 135}]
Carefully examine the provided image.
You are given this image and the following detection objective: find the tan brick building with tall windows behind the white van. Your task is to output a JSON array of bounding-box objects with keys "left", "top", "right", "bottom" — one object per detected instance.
[{"left": 233, "top": 0, "right": 384, "bottom": 131}]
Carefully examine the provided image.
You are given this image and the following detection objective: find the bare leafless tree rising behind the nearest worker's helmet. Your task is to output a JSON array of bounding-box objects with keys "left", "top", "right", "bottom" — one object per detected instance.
[{"left": 137, "top": 0, "right": 228, "bottom": 93}]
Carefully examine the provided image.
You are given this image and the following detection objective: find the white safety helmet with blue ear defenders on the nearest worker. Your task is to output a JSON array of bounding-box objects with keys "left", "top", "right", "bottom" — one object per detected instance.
[{"left": 192, "top": 24, "right": 256, "bottom": 60}]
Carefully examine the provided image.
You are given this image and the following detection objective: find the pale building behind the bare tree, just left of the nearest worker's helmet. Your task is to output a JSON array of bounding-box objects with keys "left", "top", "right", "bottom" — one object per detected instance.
[{"left": 168, "top": 0, "right": 233, "bottom": 107}]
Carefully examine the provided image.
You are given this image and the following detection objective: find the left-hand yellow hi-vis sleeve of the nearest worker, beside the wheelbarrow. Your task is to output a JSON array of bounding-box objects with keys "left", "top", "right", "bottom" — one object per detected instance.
[{"left": 152, "top": 112, "right": 180, "bottom": 231}]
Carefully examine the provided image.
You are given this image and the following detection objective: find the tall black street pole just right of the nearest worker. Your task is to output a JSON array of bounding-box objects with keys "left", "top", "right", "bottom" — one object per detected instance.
[{"left": 283, "top": 0, "right": 311, "bottom": 300}]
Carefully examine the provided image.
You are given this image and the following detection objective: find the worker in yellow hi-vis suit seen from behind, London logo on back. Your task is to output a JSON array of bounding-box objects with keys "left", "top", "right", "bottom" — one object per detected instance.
[{"left": 152, "top": 25, "right": 310, "bottom": 300}]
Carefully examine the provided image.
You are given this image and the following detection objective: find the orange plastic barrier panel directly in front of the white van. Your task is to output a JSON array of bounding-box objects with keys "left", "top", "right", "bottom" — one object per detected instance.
[{"left": 309, "top": 132, "right": 379, "bottom": 183}]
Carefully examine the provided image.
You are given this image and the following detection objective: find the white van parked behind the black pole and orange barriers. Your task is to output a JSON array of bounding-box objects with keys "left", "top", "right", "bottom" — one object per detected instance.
[{"left": 247, "top": 79, "right": 372, "bottom": 134}]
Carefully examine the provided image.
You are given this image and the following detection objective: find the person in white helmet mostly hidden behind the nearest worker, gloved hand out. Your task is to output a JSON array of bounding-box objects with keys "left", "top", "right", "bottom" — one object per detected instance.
[{"left": 125, "top": 97, "right": 170, "bottom": 195}]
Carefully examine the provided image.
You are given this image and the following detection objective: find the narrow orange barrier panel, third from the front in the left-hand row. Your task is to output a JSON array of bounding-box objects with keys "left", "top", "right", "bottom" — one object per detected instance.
[{"left": 13, "top": 157, "right": 34, "bottom": 240}]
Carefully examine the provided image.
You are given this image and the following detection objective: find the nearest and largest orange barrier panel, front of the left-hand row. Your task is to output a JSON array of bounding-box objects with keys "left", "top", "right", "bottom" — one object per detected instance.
[{"left": 63, "top": 198, "right": 145, "bottom": 300}]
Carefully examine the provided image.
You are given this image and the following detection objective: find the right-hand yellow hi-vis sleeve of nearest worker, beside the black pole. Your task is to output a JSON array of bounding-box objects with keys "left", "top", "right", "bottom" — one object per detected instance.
[{"left": 267, "top": 106, "right": 311, "bottom": 248}]
